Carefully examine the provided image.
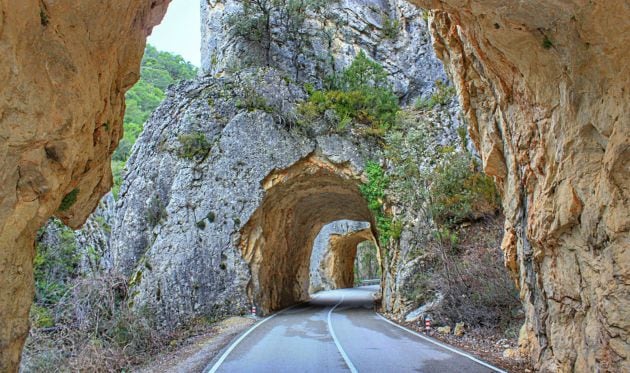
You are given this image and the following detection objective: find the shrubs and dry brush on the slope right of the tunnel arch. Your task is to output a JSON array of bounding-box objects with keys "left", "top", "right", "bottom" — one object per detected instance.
[{"left": 385, "top": 108, "right": 520, "bottom": 328}]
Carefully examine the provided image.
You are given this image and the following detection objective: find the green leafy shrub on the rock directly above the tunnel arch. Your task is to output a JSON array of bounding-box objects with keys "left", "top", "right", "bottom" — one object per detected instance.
[{"left": 299, "top": 51, "right": 400, "bottom": 133}]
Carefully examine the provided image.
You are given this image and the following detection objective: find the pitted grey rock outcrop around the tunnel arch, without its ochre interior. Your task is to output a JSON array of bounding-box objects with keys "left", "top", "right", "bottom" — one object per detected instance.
[{"left": 112, "top": 69, "right": 376, "bottom": 325}]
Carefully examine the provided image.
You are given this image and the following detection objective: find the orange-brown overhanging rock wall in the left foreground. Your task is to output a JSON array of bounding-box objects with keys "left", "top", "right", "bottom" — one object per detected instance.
[{"left": 0, "top": 0, "right": 169, "bottom": 371}]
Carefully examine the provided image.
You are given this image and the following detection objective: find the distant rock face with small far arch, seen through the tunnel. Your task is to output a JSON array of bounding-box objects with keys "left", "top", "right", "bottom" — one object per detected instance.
[{"left": 308, "top": 220, "right": 374, "bottom": 294}]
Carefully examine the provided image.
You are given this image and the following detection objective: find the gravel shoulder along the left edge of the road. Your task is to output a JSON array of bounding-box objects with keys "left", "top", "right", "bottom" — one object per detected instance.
[{"left": 134, "top": 316, "right": 255, "bottom": 373}]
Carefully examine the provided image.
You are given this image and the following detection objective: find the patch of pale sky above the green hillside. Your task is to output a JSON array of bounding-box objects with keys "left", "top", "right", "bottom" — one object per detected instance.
[{"left": 149, "top": 0, "right": 201, "bottom": 67}]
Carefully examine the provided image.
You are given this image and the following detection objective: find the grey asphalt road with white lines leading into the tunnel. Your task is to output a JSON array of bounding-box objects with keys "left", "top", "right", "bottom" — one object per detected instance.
[{"left": 205, "top": 286, "right": 501, "bottom": 373}]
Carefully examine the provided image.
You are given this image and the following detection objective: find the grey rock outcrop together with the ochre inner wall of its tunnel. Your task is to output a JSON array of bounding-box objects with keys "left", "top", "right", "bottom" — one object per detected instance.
[{"left": 112, "top": 69, "right": 378, "bottom": 325}]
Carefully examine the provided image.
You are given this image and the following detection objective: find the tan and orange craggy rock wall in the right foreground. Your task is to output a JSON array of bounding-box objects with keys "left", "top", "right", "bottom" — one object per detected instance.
[{"left": 415, "top": 0, "right": 630, "bottom": 372}]
